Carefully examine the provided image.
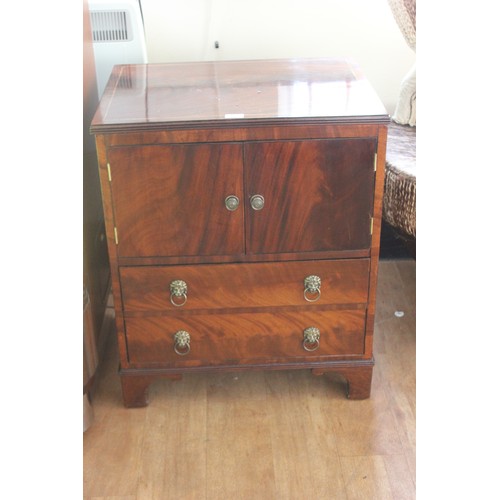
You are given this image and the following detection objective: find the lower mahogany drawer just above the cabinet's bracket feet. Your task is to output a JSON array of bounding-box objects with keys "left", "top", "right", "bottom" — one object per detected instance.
[{"left": 125, "top": 310, "right": 365, "bottom": 367}]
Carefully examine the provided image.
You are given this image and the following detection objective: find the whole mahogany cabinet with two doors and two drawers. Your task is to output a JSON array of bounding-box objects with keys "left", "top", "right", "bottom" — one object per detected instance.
[{"left": 91, "top": 59, "right": 388, "bottom": 407}]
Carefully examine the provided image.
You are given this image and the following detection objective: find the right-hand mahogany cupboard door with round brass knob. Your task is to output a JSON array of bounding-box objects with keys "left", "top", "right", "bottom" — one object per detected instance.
[{"left": 245, "top": 139, "right": 376, "bottom": 254}]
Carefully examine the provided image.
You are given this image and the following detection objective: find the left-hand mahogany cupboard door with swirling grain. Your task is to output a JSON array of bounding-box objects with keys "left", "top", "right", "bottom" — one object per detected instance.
[{"left": 108, "top": 144, "right": 245, "bottom": 257}]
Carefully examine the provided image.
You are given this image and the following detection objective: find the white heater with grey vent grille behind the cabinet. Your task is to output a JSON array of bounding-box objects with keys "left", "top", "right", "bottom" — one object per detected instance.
[{"left": 89, "top": 0, "right": 147, "bottom": 99}]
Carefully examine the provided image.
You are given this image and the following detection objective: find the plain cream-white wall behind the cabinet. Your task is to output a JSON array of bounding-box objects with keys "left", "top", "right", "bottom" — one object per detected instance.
[{"left": 141, "top": 0, "right": 415, "bottom": 114}]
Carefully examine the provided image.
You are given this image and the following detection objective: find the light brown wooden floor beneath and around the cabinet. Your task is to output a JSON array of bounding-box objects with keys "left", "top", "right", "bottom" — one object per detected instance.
[{"left": 83, "top": 260, "right": 416, "bottom": 500}]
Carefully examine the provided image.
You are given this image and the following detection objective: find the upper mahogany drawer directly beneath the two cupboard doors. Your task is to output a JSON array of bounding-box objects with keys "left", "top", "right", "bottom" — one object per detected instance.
[{"left": 120, "top": 259, "right": 370, "bottom": 314}]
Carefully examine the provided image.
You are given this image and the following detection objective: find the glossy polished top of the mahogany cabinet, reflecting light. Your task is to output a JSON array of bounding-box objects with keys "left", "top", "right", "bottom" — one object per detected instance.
[{"left": 91, "top": 59, "right": 388, "bottom": 132}]
